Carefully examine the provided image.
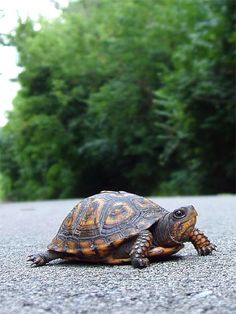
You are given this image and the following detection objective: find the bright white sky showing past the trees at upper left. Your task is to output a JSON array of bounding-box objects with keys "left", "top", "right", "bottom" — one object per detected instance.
[{"left": 0, "top": 0, "right": 69, "bottom": 127}]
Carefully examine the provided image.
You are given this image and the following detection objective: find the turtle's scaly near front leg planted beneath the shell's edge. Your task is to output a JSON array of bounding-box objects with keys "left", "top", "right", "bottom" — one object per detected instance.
[{"left": 130, "top": 230, "right": 153, "bottom": 268}]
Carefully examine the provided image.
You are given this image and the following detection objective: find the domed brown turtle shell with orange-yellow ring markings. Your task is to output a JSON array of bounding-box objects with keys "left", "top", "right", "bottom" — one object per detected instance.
[{"left": 48, "top": 192, "right": 167, "bottom": 260}]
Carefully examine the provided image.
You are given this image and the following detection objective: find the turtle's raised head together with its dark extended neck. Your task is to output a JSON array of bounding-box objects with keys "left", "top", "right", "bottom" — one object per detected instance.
[{"left": 154, "top": 205, "right": 197, "bottom": 246}]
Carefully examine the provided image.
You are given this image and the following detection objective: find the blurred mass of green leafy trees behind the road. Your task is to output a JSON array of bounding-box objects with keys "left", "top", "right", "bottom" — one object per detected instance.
[{"left": 0, "top": 0, "right": 236, "bottom": 200}]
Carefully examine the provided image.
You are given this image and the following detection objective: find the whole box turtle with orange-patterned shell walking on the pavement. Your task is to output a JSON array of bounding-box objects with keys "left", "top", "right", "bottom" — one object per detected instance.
[{"left": 28, "top": 191, "right": 216, "bottom": 268}]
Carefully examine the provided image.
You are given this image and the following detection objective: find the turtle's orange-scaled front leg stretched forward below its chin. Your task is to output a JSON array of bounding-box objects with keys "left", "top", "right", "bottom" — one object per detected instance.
[{"left": 189, "top": 228, "right": 216, "bottom": 255}]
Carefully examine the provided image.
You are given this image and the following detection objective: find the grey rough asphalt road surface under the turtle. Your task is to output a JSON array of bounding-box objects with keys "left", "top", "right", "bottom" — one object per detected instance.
[{"left": 0, "top": 195, "right": 236, "bottom": 314}]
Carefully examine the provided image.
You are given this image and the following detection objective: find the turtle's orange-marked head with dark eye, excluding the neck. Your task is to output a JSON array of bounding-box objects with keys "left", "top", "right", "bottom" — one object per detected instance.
[{"left": 168, "top": 205, "right": 197, "bottom": 243}]
